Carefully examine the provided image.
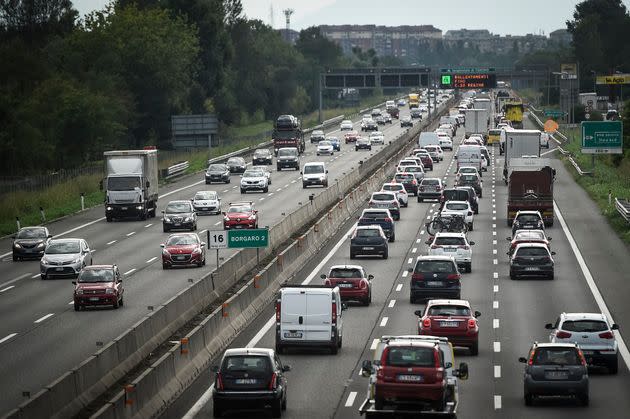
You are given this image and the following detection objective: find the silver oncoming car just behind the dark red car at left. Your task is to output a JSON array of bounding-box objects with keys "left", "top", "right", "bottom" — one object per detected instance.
[{"left": 39, "top": 239, "right": 92, "bottom": 279}]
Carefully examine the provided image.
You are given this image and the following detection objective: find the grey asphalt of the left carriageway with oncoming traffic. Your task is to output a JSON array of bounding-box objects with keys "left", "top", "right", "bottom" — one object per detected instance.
[{"left": 0, "top": 106, "right": 434, "bottom": 414}]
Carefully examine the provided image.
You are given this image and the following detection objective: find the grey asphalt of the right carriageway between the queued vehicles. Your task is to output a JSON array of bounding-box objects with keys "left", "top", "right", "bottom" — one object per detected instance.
[{"left": 163, "top": 115, "right": 630, "bottom": 419}]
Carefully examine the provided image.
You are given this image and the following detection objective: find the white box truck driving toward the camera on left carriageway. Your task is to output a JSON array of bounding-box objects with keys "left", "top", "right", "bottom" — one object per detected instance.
[{"left": 102, "top": 149, "right": 158, "bottom": 222}]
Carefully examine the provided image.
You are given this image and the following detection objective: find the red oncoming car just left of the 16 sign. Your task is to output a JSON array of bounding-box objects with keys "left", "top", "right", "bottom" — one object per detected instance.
[{"left": 160, "top": 233, "right": 206, "bottom": 269}]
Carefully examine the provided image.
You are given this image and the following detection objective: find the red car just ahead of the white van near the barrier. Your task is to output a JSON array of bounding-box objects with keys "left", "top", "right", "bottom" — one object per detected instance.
[{"left": 321, "top": 265, "right": 374, "bottom": 306}]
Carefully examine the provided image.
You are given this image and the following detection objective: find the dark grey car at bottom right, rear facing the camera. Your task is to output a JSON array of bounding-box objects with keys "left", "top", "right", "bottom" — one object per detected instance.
[{"left": 518, "top": 343, "right": 589, "bottom": 406}]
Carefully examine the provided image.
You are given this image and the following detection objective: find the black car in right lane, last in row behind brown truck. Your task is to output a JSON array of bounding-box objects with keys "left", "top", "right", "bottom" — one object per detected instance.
[{"left": 510, "top": 243, "right": 556, "bottom": 279}]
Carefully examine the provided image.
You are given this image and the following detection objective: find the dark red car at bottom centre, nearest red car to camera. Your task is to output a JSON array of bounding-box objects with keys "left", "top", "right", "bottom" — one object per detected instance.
[{"left": 374, "top": 340, "right": 447, "bottom": 411}]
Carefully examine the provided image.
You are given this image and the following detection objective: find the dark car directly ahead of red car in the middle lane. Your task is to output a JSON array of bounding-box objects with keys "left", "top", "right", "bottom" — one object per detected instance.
[{"left": 408, "top": 256, "right": 462, "bottom": 304}]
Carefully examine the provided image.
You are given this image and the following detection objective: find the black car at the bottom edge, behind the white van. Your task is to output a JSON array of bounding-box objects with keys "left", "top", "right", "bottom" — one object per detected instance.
[{"left": 212, "top": 348, "right": 291, "bottom": 418}]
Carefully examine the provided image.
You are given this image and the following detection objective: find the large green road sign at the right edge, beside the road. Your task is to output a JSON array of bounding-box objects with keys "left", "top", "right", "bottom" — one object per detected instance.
[{"left": 582, "top": 121, "right": 623, "bottom": 154}]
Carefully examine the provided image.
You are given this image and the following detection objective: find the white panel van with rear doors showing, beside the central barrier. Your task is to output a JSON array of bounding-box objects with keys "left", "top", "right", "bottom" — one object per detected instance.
[{"left": 276, "top": 285, "right": 346, "bottom": 354}]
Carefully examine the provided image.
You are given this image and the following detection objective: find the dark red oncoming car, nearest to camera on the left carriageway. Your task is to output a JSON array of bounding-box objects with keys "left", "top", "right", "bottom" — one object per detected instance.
[{"left": 72, "top": 265, "right": 125, "bottom": 311}]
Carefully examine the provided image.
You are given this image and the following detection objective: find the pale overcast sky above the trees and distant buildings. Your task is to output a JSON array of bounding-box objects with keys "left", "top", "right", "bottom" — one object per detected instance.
[{"left": 73, "top": 0, "right": 630, "bottom": 35}]
